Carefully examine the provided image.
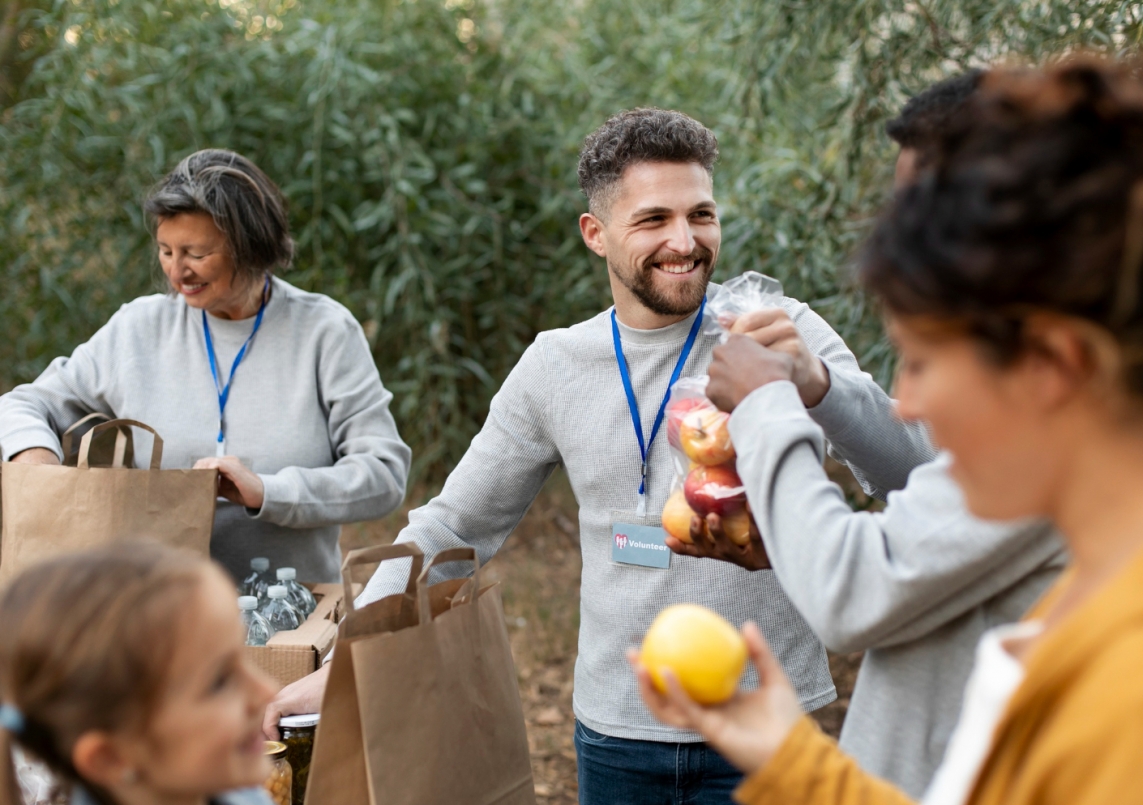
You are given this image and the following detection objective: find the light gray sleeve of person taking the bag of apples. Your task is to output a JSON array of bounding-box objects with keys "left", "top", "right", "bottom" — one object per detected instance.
[{"left": 730, "top": 381, "right": 1062, "bottom": 652}]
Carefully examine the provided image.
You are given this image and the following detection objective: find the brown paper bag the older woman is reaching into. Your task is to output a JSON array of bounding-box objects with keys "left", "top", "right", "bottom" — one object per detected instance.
[{"left": 0, "top": 420, "right": 218, "bottom": 584}]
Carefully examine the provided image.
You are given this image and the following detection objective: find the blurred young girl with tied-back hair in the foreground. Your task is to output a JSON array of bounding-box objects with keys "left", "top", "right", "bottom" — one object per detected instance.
[{"left": 0, "top": 544, "right": 273, "bottom": 805}]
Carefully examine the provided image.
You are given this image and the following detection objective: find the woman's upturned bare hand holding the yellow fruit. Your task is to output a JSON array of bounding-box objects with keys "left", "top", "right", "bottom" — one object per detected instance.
[{"left": 628, "top": 623, "right": 802, "bottom": 774}]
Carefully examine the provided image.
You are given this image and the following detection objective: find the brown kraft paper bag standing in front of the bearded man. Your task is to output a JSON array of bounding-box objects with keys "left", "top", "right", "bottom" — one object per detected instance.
[{"left": 305, "top": 543, "right": 536, "bottom": 805}]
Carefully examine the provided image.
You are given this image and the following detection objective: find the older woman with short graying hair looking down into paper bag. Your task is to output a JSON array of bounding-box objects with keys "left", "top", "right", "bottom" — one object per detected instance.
[{"left": 0, "top": 150, "right": 410, "bottom": 582}]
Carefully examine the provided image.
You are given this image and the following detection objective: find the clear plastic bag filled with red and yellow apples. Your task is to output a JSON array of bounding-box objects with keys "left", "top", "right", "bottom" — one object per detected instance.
[{"left": 662, "top": 271, "right": 783, "bottom": 545}]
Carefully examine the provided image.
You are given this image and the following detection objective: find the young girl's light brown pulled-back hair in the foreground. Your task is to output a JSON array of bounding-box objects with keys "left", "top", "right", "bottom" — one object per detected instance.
[{"left": 0, "top": 543, "right": 218, "bottom": 805}]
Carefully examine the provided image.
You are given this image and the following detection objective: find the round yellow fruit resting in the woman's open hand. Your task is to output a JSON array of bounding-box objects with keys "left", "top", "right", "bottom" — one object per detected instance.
[{"left": 639, "top": 604, "right": 746, "bottom": 704}]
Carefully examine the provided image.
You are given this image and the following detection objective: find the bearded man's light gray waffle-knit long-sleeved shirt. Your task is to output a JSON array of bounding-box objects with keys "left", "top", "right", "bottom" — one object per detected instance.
[{"left": 358, "top": 286, "right": 933, "bottom": 742}]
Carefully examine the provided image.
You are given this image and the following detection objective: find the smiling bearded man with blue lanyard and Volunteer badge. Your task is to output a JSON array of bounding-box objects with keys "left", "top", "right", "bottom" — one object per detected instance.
[{"left": 265, "top": 109, "right": 933, "bottom": 805}]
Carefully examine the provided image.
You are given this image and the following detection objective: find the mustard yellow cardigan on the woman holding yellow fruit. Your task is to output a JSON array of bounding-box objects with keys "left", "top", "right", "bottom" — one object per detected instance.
[{"left": 735, "top": 555, "right": 1143, "bottom": 805}]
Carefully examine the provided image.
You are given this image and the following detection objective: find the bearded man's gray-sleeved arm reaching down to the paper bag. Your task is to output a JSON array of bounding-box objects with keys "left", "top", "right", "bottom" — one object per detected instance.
[{"left": 358, "top": 341, "right": 560, "bottom": 606}]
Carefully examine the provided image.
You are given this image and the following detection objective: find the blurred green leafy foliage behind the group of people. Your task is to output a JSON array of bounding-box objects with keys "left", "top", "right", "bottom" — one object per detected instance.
[{"left": 0, "top": 0, "right": 1143, "bottom": 481}]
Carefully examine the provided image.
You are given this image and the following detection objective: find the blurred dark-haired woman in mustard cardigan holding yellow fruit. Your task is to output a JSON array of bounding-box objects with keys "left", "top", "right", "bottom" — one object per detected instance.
[{"left": 638, "top": 58, "right": 1143, "bottom": 805}]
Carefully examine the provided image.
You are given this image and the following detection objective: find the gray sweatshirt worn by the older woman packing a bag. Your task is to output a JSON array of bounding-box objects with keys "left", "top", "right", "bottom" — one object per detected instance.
[{"left": 0, "top": 279, "right": 410, "bottom": 582}]
